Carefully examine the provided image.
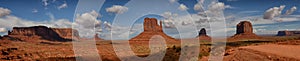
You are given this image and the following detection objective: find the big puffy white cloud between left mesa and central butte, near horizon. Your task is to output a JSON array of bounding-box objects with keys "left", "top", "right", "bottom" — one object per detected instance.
[{"left": 73, "top": 10, "right": 102, "bottom": 37}]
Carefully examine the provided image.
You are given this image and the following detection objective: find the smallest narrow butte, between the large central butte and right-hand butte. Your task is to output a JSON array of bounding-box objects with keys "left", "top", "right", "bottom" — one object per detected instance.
[{"left": 197, "top": 28, "right": 211, "bottom": 41}]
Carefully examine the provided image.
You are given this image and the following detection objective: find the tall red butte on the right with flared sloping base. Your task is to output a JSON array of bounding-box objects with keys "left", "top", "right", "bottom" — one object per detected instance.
[{"left": 230, "top": 21, "right": 260, "bottom": 39}]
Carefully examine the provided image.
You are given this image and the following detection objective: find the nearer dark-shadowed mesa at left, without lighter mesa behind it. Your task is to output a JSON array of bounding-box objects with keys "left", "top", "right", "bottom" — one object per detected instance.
[{"left": 8, "top": 26, "right": 64, "bottom": 41}]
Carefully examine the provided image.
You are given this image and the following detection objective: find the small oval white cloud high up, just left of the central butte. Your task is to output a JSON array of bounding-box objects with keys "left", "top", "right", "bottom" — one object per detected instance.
[{"left": 106, "top": 5, "right": 128, "bottom": 14}]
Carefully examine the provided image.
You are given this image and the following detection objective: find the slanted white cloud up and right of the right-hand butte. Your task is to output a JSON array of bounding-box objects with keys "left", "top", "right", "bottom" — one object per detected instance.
[{"left": 263, "top": 5, "right": 285, "bottom": 19}]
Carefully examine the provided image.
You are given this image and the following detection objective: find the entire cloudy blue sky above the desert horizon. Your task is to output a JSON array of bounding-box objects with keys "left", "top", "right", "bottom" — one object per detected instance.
[{"left": 0, "top": 0, "right": 300, "bottom": 40}]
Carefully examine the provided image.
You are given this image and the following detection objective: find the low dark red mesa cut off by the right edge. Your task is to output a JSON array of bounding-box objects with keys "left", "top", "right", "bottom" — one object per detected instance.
[{"left": 277, "top": 31, "right": 300, "bottom": 36}]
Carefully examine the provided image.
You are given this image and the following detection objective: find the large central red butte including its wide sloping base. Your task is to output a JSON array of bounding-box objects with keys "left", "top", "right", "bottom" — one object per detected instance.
[{"left": 129, "top": 18, "right": 179, "bottom": 43}]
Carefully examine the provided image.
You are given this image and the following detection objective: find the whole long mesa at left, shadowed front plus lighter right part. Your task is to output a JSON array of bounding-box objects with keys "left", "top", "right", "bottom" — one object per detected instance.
[{"left": 7, "top": 26, "right": 78, "bottom": 42}]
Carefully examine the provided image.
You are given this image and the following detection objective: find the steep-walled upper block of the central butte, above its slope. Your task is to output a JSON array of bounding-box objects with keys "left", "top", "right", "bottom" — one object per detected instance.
[{"left": 144, "top": 18, "right": 163, "bottom": 32}]
